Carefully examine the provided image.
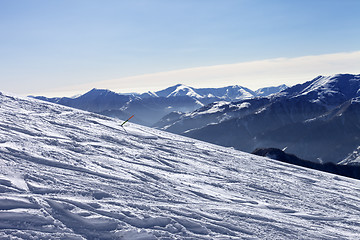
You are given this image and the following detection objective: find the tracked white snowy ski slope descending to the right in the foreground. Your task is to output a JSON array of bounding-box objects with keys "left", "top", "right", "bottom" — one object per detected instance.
[{"left": 0, "top": 91, "right": 360, "bottom": 239}]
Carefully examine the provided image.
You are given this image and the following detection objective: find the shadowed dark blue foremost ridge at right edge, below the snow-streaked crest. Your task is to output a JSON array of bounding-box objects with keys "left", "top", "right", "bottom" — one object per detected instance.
[{"left": 258, "top": 98, "right": 360, "bottom": 163}]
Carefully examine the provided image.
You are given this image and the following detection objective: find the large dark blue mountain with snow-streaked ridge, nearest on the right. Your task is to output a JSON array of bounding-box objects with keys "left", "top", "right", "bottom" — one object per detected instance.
[{"left": 156, "top": 74, "right": 360, "bottom": 163}]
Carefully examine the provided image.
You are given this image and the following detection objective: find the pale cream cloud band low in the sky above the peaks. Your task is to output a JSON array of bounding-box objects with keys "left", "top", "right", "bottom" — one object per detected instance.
[{"left": 27, "top": 51, "right": 360, "bottom": 97}]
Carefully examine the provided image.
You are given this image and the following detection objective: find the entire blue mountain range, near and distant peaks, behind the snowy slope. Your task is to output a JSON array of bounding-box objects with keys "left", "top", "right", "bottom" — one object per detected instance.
[{"left": 33, "top": 74, "right": 360, "bottom": 165}]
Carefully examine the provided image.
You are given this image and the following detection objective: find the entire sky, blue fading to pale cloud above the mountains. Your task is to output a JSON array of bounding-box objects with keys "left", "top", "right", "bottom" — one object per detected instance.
[{"left": 0, "top": 0, "right": 360, "bottom": 97}]
